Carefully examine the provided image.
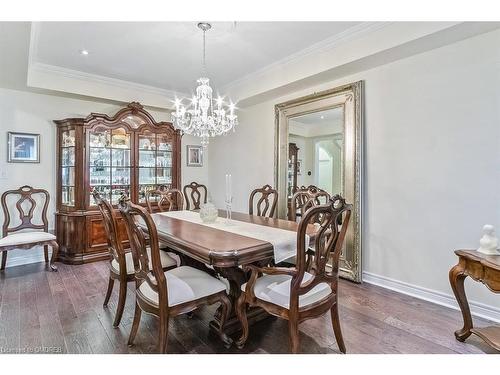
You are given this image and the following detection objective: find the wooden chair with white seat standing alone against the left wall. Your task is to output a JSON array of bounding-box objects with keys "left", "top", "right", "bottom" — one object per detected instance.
[{"left": 0, "top": 185, "right": 59, "bottom": 271}]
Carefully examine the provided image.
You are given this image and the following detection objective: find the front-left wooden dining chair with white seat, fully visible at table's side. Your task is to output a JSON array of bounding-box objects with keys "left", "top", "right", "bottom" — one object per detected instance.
[{"left": 119, "top": 197, "right": 232, "bottom": 353}]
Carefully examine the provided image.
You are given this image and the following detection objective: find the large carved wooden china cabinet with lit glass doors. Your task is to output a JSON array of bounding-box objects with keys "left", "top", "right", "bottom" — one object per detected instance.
[{"left": 54, "top": 102, "right": 181, "bottom": 264}]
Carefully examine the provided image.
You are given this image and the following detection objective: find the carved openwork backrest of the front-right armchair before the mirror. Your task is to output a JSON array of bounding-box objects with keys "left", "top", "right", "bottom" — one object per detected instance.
[{"left": 290, "top": 195, "right": 352, "bottom": 308}]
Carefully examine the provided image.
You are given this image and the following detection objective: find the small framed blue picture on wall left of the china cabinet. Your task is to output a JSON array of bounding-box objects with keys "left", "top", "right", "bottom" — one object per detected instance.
[{"left": 7, "top": 132, "right": 40, "bottom": 163}]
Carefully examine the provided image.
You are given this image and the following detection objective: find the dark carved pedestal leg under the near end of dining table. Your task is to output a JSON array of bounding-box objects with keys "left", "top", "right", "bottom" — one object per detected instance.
[{"left": 210, "top": 267, "right": 271, "bottom": 335}]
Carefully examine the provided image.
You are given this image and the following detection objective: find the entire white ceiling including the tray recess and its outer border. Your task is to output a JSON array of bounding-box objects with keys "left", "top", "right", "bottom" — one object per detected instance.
[{"left": 0, "top": 22, "right": 500, "bottom": 109}]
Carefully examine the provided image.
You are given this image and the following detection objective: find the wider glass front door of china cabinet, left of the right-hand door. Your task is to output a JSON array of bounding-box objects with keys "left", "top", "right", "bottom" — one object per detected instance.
[{"left": 89, "top": 128, "right": 131, "bottom": 206}]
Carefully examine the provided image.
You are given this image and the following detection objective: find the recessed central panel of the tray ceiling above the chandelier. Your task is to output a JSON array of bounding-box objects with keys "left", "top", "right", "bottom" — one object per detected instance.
[{"left": 30, "top": 22, "right": 360, "bottom": 93}]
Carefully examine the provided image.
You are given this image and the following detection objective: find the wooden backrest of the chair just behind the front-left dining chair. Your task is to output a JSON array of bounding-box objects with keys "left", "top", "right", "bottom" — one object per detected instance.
[{"left": 92, "top": 189, "right": 127, "bottom": 275}]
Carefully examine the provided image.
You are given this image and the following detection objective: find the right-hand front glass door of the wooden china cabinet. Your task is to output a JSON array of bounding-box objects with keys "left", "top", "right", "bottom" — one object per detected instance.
[{"left": 138, "top": 132, "right": 172, "bottom": 203}]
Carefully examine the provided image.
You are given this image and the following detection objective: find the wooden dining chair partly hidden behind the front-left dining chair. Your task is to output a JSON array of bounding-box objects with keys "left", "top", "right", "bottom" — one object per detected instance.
[{"left": 92, "top": 190, "right": 177, "bottom": 327}]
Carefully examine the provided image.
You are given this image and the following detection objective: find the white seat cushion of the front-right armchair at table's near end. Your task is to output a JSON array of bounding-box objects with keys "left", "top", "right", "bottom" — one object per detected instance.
[{"left": 241, "top": 272, "right": 332, "bottom": 309}]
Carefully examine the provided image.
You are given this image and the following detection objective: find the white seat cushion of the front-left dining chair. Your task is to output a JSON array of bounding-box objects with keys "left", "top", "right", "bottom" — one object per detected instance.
[{"left": 139, "top": 266, "right": 226, "bottom": 307}]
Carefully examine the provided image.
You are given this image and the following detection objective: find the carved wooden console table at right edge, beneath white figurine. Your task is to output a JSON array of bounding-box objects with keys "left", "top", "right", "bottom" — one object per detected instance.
[{"left": 449, "top": 250, "right": 500, "bottom": 351}]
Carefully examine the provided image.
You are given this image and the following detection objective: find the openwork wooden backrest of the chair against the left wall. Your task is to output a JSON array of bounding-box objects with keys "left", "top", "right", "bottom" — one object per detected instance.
[{"left": 1, "top": 185, "right": 50, "bottom": 237}]
